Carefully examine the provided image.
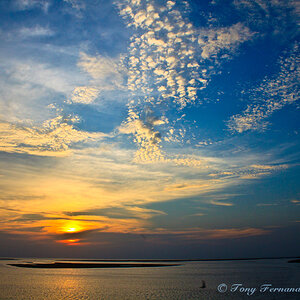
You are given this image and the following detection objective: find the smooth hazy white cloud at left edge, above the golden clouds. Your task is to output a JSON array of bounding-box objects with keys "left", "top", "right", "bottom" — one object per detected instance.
[{"left": 0, "top": 57, "right": 88, "bottom": 123}]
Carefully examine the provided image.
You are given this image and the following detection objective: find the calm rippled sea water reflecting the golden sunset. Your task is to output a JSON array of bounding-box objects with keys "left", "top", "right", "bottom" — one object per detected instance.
[{"left": 0, "top": 258, "right": 300, "bottom": 300}]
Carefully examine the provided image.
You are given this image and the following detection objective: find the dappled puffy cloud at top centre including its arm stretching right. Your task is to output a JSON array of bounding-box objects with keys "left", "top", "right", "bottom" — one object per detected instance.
[{"left": 119, "top": 1, "right": 253, "bottom": 108}]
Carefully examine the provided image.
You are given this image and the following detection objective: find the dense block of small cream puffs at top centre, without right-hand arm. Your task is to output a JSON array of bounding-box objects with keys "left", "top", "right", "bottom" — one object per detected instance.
[{"left": 119, "top": 1, "right": 204, "bottom": 107}]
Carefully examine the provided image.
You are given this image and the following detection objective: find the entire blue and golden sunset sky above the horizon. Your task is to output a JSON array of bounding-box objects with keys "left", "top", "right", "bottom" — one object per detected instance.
[{"left": 0, "top": 0, "right": 300, "bottom": 258}]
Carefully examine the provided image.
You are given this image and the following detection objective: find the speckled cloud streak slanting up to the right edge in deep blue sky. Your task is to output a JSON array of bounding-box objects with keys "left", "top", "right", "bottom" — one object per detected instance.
[{"left": 227, "top": 44, "right": 300, "bottom": 133}]
